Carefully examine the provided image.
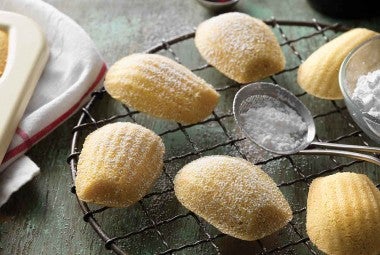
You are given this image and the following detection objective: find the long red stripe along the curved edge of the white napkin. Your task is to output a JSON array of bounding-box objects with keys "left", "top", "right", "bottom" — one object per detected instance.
[{"left": 2, "top": 63, "right": 107, "bottom": 163}]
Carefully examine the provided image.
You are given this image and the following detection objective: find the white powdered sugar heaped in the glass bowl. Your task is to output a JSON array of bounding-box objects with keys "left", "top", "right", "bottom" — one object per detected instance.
[{"left": 352, "top": 69, "right": 380, "bottom": 118}]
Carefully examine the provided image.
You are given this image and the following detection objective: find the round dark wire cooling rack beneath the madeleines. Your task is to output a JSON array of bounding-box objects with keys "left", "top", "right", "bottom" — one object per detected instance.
[{"left": 68, "top": 18, "right": 379, "bottom": 254}]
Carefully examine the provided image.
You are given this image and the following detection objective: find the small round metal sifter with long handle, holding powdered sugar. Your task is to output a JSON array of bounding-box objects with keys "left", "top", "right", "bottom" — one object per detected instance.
[{"left": 233, "top": 82, "right": 380, "bottom": 166}]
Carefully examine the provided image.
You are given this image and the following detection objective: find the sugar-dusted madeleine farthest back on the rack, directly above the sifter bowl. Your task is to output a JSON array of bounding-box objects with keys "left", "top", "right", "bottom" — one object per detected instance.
[{"left": 195, "top": 12, "right": 285, "bottom": 83}]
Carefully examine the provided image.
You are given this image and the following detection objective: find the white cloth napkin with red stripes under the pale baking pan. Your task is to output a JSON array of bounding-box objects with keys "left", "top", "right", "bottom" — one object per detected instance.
[{"left": 0, "top": 0, "right": 107, "bottom": 206}]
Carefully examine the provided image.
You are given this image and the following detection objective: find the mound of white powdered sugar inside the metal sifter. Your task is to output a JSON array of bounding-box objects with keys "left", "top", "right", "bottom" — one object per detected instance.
[{"left": 241, "top": 101, "right": 307, "bottom": 151}]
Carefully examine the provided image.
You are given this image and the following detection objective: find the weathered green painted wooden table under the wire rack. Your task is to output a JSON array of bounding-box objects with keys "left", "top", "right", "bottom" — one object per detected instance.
[{"left": 0, "top": 0, "right": 380, "bottom": 254}]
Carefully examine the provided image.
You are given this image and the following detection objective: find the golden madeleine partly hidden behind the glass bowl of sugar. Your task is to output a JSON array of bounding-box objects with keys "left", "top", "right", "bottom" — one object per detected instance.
[{"left": 297, "top": 28, "right": 377, "bottom": 99}]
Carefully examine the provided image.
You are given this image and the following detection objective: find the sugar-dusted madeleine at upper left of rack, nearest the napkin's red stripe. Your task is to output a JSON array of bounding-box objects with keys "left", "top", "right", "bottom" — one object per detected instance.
[{"left": 104, "top": 54, "right": 219, "bottom": 124}]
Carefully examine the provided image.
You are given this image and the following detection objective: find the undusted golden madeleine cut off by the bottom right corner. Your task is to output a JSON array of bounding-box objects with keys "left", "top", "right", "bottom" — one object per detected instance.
[{"left": 306, "top": 173, "right": 380, "bottom": 255}]
